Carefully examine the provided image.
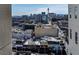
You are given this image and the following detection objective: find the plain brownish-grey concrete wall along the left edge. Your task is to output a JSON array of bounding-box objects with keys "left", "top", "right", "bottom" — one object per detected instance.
[{"left": 0, "top": 4, "right": 12, "bottom": 55}]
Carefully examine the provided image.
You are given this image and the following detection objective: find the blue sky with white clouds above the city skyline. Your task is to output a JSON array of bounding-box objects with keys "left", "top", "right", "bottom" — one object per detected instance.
[{"left": 12, "top": 4, "right": 68, "bottom": 16}]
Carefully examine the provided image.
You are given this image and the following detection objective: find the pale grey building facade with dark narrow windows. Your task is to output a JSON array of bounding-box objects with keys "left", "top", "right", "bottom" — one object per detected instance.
[{"left": 66, "top": 4, "right": 79, "bottom": 55}]
